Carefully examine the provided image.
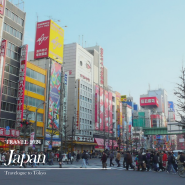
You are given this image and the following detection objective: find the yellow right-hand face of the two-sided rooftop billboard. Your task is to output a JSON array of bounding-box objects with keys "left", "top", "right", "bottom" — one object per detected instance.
[{"left": 49, "top": 20, "right": 64, "bottom": 64}]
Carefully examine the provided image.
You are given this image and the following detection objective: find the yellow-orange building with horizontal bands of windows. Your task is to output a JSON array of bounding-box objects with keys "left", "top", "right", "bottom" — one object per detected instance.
[{"left": 23, "top": 62, "right": 47, "bottom": 150}]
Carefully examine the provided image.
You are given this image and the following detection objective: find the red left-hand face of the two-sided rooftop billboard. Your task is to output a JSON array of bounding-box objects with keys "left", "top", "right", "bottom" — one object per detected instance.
[{"left": 34, "top": 20, "right": 50, "bottom": 59}]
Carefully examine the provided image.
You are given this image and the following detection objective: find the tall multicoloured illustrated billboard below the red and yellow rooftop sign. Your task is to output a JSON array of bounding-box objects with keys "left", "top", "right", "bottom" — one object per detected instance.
[{"left": 48, "top": 61, "right": 61, "bottom": 129}]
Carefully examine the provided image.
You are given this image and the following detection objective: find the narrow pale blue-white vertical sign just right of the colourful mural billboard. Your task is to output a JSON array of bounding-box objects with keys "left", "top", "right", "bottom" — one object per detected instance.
[{"left": 63, "top": 71, "right": 69, "bottom": 125}]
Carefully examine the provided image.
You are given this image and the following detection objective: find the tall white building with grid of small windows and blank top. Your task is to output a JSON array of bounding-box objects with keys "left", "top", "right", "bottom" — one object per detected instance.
[{"left": 64, "top": 43, "right": 94, "bottom": 151}]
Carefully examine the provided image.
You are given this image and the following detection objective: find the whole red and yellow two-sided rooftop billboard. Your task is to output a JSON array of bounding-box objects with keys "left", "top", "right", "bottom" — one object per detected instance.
[{"left": 34, "top": 20, "right": 64, "bottom": 64}]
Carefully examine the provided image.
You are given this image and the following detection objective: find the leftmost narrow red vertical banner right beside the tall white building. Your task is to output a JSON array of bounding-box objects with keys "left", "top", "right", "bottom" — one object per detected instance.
[{"left": 95, "top": 85, "right": 100, "bottom": 130}]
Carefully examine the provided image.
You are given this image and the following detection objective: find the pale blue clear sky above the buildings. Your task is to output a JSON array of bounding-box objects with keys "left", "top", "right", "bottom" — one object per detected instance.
[{"left": 18, "top": 0, "right": 185, "bottom": 111}]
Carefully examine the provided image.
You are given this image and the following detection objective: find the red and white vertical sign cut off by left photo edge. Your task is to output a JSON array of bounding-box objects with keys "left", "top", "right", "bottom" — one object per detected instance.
[{"left": 0, "top": 40, "right": 7, "bottom": 113}]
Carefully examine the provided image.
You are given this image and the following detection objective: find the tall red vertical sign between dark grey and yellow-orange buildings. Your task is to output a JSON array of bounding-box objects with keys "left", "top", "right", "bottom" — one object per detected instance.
[{"left": 16, "top": 44, "right": 28, "bottom": 126}]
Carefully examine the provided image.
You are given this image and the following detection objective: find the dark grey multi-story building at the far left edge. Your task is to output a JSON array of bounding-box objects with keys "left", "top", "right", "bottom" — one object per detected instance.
[{"left": 0, "top": 1, "right": 26, "bottom": 128}]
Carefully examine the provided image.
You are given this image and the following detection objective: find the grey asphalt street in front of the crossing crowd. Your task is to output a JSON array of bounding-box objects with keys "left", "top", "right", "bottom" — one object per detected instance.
[{"left": 0, "top": 159, "right": 184, "bottom": 185}]
